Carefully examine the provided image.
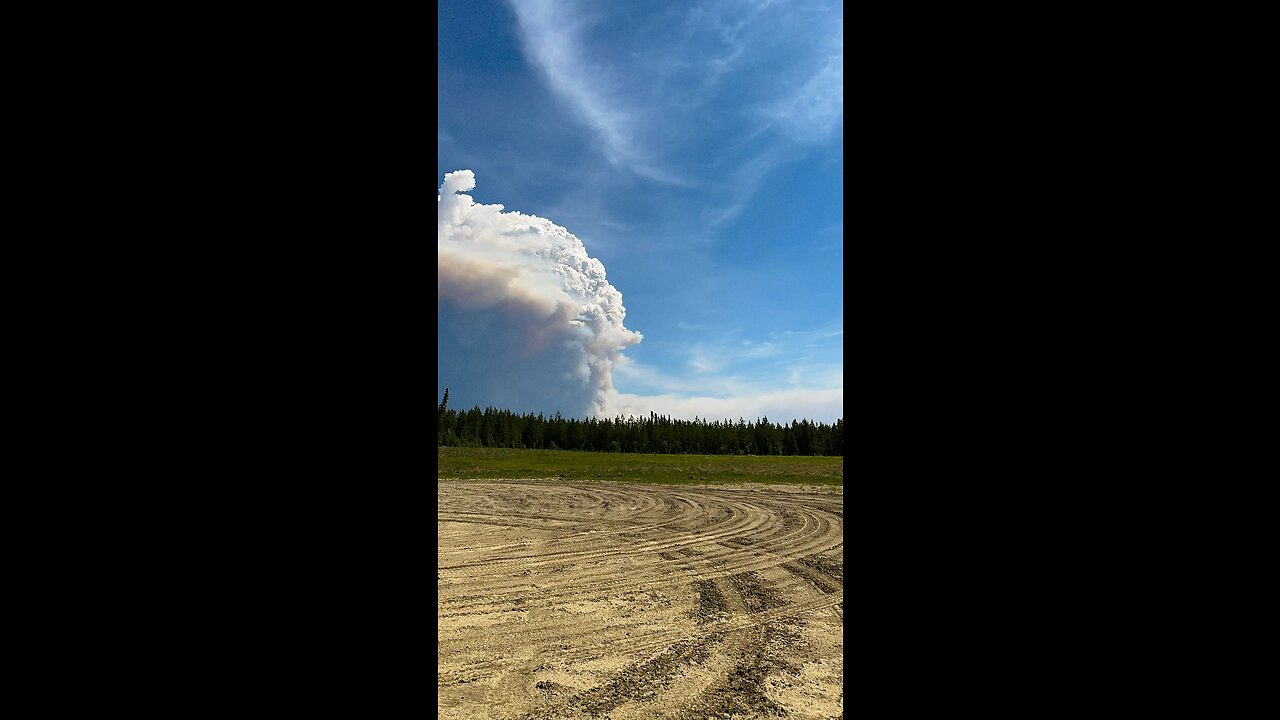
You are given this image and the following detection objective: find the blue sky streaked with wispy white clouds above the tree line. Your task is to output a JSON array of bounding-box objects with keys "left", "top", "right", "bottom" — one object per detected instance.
[{"left": 435, "top": 0, "right": 844, "bottom": 423}]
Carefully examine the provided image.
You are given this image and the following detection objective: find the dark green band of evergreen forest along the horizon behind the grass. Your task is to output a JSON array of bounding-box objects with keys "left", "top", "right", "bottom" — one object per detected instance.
[{"left": 436, "top": 389, "right": 845, "bottom": 456}]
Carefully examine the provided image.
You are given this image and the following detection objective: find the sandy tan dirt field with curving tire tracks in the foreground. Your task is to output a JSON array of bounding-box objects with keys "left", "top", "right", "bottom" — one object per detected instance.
[{"left": 436, "top": 480, "right": 845, "bottom": 720}]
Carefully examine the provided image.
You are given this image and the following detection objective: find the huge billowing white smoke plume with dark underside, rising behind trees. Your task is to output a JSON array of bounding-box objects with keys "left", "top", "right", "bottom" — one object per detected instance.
[{"left": 436, "top": 170, "right": 641, "bottom": 418}]
